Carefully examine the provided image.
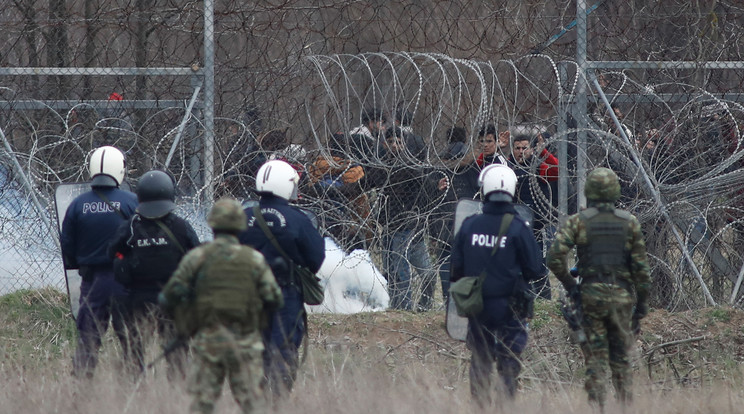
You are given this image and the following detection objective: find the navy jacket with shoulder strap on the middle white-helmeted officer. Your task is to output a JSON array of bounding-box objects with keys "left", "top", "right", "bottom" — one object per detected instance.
[{"left": 238, "top": 195, "right": 325, "bottom": 286}]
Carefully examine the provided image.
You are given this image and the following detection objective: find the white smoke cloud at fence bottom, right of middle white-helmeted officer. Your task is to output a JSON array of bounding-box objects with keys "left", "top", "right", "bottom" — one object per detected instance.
[{"left": 307, "top": 238, "right": 390, "bottom": 314}]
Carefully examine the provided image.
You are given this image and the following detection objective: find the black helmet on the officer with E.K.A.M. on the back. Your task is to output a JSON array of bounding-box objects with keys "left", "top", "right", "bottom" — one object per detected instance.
[{"left": 137, "top": 170, "right": 176, "bottom": 219}]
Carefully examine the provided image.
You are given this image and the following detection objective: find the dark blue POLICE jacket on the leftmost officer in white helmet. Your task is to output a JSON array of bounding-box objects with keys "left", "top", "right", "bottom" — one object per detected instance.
[{"left": 60, "top": 187, "right": 137, "bottom": 269}]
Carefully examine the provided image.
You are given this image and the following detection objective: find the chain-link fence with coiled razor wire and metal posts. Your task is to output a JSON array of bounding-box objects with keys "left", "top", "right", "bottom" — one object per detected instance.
[{"left": 0, "top": 0, "right": 744, "bottom": 309}]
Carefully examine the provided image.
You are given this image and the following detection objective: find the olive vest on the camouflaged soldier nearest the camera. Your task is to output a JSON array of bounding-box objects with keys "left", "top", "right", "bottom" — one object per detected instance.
[{"left": 195, "top": 244, "right": 263, "bottom": 333}]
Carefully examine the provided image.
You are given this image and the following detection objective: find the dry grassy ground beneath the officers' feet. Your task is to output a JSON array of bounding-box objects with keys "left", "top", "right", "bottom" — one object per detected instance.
[{"left": 0, "top": 292, "right": 744, "bottom": 414}]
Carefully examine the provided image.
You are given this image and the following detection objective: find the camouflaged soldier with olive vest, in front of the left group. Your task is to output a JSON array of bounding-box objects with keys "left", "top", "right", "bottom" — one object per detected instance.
[{"left": 159, "top": 198, "right": 282, "bottom": 414}]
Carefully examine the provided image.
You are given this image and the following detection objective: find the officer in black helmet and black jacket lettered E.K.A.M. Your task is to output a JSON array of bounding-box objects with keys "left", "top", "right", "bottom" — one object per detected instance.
[{"left": 108, "top": 170, "right": 199, "bottom": 373}]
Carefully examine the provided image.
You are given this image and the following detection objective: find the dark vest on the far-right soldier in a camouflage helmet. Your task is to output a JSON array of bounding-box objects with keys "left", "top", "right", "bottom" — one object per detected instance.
[{"left": 577, "top": 207, "right": 630, "bottom": 279}]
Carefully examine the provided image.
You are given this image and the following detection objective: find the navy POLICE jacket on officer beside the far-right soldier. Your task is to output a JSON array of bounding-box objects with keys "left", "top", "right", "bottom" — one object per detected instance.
[{"left": 451, "top": 202, "right": 542, "bottom": 299}]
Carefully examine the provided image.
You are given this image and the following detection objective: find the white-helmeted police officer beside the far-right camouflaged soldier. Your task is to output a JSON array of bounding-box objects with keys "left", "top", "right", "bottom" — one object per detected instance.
[{"left": 451, "top": 164, "right": 542, "bottom": 407}]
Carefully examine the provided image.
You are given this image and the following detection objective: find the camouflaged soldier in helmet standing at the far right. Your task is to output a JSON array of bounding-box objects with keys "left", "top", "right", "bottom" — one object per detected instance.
[{"left": 547, "top": 168, "right": 651, "bottom": 407}]
